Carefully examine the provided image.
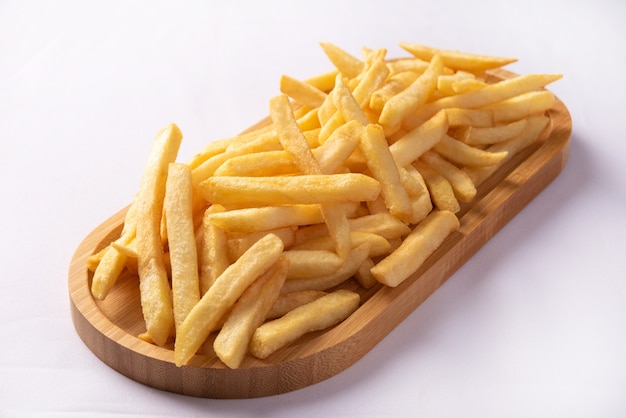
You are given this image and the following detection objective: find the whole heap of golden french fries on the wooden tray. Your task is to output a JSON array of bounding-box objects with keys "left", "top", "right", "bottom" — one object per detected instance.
[{"left": 88, "top": 43, "right": 561, "bottom": 368}]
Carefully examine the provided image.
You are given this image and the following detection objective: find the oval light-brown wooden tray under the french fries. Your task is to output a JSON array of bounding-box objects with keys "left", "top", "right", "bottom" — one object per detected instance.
[{"left": 69, "top": 70, "right": 571, "bottom": 398}]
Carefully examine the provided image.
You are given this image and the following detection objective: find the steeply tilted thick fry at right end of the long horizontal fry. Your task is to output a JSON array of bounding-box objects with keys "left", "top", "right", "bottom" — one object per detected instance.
[{"left": 361, "top": 124, "right": 412, "bottom": 221}]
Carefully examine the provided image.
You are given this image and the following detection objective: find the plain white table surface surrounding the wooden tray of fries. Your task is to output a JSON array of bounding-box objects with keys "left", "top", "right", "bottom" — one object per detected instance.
[{"left": 0, "top": 0, "right": 626, "bottom": 417}]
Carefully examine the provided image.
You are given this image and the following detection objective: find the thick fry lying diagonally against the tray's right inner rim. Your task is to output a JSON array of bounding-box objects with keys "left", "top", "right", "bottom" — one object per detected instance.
[{"left": 371, "top": 211, "right": 459, "bottom": 287}]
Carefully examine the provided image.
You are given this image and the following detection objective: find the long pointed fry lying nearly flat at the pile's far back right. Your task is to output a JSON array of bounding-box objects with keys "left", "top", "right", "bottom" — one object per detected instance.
[{"left": 400, "top": 42, "right": 517, "bottom": 71}]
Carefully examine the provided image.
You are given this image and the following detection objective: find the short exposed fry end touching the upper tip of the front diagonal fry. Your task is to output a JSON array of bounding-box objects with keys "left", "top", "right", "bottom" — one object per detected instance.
[{"left": 284, "top": 250, "right": 343, "bottom": 280}]
